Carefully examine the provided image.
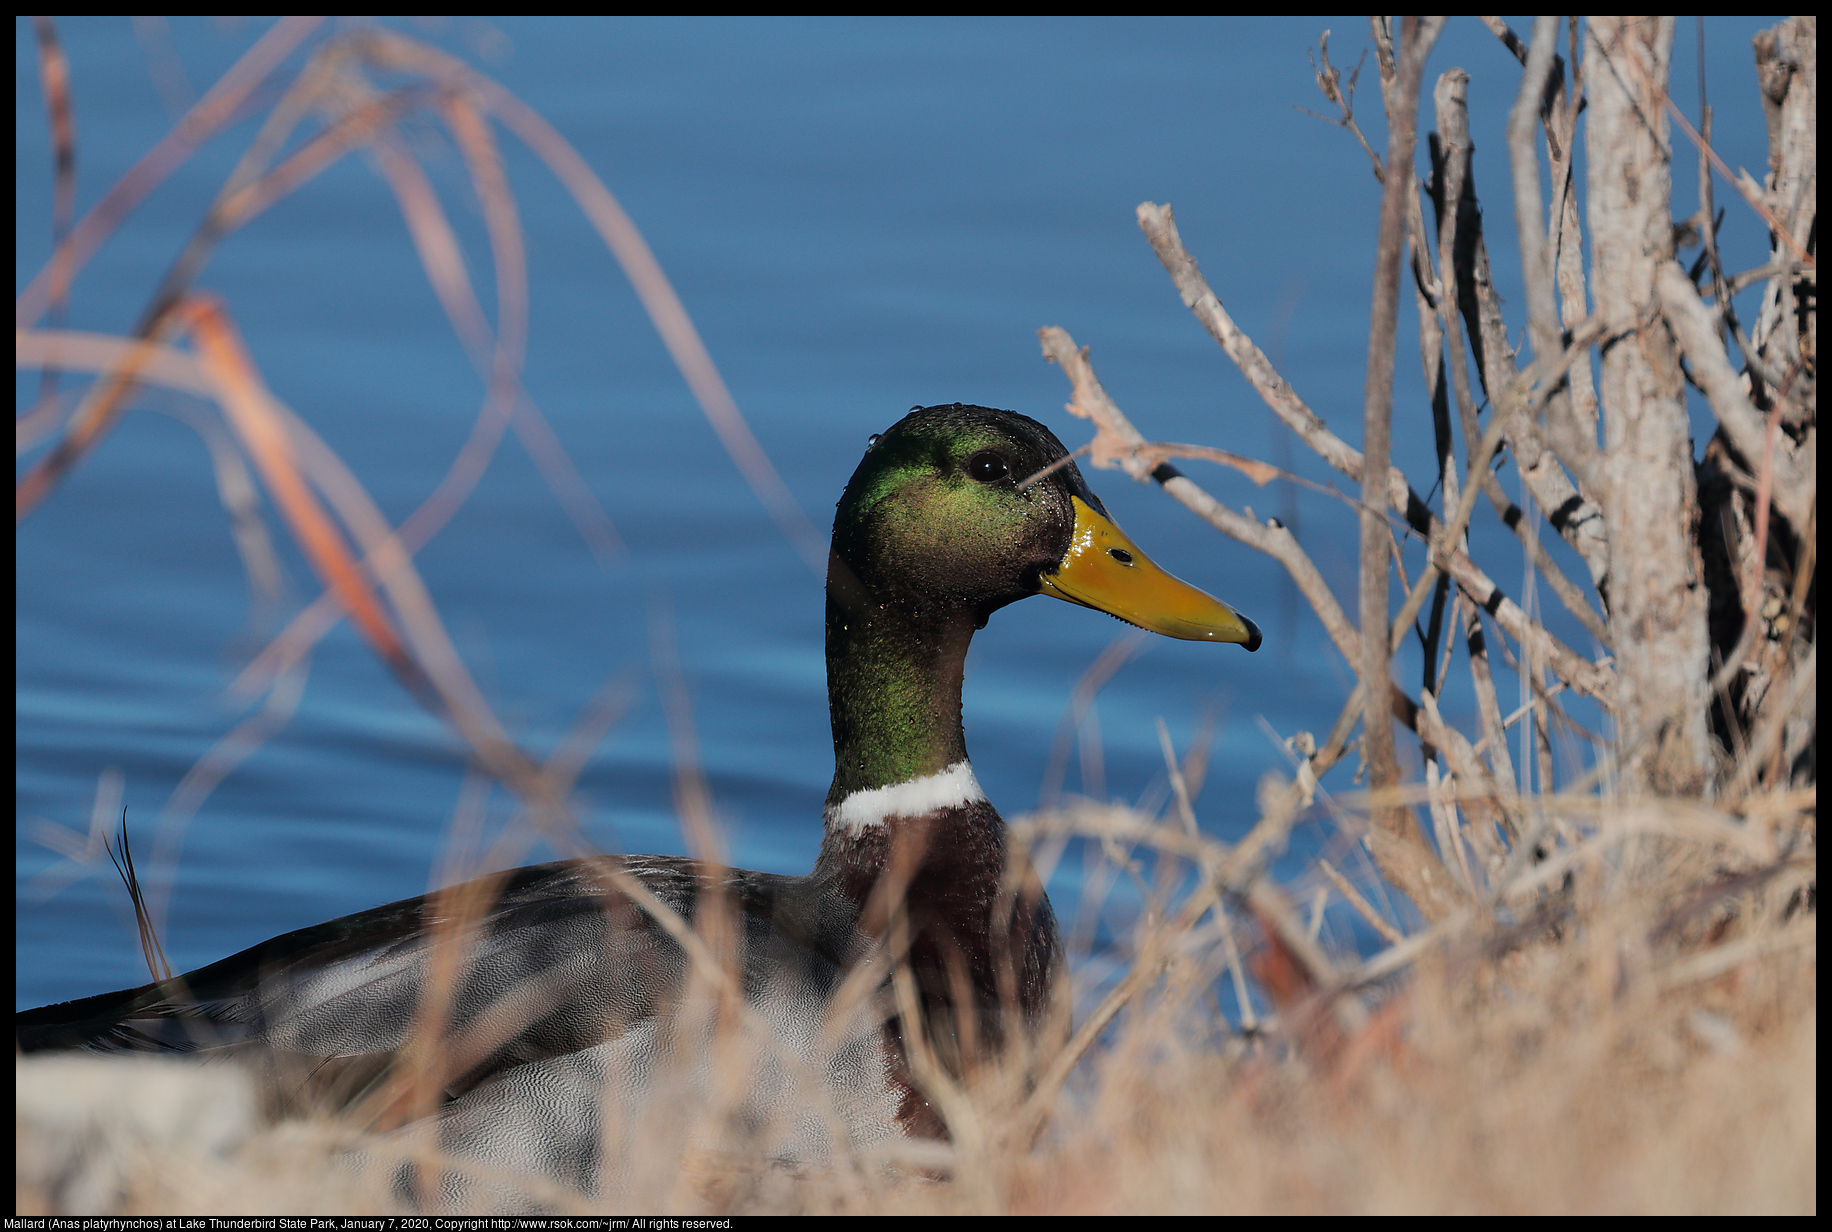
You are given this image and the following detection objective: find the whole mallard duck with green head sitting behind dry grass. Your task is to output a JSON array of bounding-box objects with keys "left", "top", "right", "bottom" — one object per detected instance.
[{"left": 16, "top": 403, "right": 1260, "bottom": 1192}]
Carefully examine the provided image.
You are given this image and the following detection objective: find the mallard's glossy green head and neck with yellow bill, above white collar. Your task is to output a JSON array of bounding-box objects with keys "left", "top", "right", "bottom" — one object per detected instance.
[{"left": 826, "top": 403, "right": 1260, "bottom": 807}]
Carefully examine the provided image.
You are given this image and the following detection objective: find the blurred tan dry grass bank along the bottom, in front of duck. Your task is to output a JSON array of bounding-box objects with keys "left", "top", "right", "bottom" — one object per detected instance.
[{"left": 18, "top": 784, "right": 1817, "bottom": 1214}]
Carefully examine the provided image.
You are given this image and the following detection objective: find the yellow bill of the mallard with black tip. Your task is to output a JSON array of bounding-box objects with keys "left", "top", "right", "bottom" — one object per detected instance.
[{"left": 1042, "top": 497, "right": 1260, "bottom": 651}]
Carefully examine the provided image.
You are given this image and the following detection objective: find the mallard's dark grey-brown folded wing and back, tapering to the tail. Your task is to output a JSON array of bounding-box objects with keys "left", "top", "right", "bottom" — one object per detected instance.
[{"left": 16, "top": 856, "right": 861, "bottom": 1100}]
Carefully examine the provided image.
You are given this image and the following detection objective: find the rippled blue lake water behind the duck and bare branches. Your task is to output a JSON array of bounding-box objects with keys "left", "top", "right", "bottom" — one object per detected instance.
[{"left": 15, "top": 18, "right": 1772, "bottom": 1007}]
